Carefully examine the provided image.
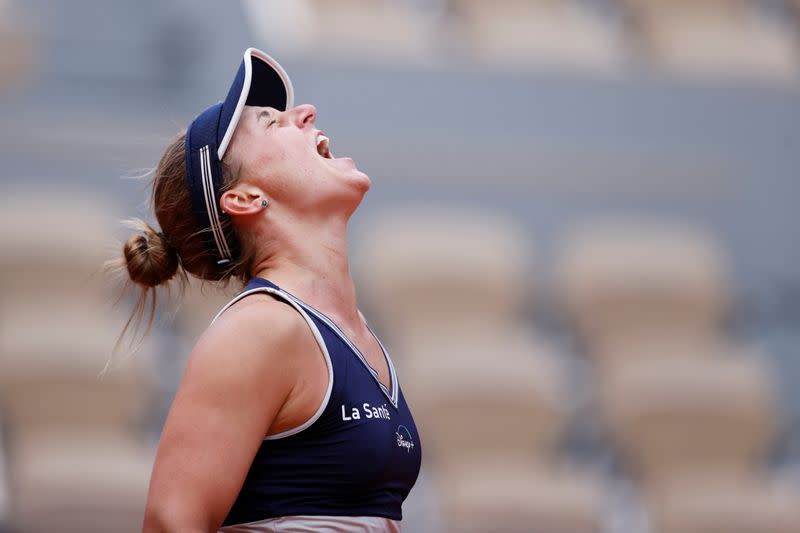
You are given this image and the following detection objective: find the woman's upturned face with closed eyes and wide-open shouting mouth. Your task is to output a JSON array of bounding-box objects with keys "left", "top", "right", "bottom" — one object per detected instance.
[{"left": 225, "top": 105, "right": 370, "bottom": 213}]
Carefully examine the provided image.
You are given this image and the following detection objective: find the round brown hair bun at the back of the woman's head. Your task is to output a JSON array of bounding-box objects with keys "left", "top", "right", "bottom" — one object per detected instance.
[{"left": 122, "top": 221, "right": 180, "bottom": 287}]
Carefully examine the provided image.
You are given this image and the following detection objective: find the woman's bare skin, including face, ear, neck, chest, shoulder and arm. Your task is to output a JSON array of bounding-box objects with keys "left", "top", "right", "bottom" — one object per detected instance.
[{"left": 143, "top": 105, "right": 390, "bottom": 533}]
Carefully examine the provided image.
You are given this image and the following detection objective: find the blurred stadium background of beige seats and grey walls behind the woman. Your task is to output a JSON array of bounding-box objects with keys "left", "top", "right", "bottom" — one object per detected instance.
[{"left": 0, "top": 0, "right": 800, "bottom": 533}]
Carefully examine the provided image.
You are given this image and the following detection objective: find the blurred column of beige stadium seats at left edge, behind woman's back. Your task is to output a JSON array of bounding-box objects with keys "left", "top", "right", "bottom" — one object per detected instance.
[{"left": 0, "top": 189, "right": 153, "bottom": 533}]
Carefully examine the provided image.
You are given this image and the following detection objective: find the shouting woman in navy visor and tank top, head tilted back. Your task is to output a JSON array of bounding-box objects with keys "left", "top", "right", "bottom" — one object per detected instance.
[{"left": 118, "top": 48, "right": 420, "bottom": 533}]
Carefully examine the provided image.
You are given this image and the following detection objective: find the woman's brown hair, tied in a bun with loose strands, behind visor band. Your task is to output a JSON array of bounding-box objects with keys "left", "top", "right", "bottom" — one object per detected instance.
[{"left": 108, "top": 131, "right": 254, "bottom": 345}]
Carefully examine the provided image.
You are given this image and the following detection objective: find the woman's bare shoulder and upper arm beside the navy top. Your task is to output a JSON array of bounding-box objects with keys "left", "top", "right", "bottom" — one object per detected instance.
[{"left": 145, "top": 295, "right": 306, "bottom": 531}]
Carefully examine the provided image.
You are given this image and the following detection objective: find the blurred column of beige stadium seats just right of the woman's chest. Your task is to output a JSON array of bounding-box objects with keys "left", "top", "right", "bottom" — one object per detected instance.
[{"left": 358, "top": 208, "right": 601, "bottom": 532}]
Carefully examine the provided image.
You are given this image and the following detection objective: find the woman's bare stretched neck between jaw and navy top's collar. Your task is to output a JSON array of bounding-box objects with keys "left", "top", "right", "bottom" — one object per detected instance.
[{"left": 248, "top": 213, "right": 359, "bottom": 324}]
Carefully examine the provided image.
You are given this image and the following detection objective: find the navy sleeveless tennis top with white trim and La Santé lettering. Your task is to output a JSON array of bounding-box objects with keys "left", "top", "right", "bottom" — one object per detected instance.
[{"left": 217, "top": 278, "right": 421, "bottom": 526}]
